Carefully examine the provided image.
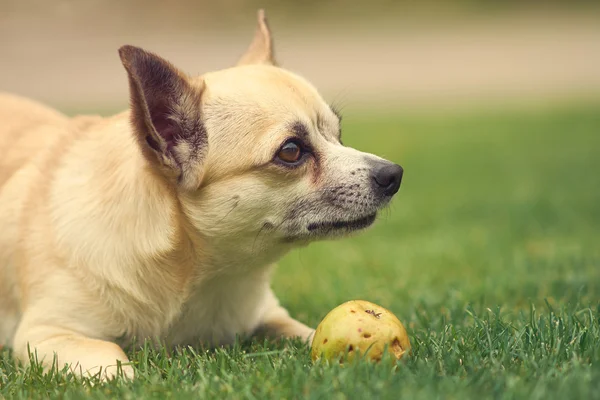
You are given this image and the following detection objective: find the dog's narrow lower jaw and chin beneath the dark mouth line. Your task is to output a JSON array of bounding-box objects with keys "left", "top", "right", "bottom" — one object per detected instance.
[{"left": 286, "top": 212, "right": 377, "bottom": 243}]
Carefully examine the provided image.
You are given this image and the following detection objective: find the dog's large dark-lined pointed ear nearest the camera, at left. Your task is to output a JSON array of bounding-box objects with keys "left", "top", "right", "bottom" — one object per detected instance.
[{"left": 119, "top": 46, "right": 207, "bottom": 190}]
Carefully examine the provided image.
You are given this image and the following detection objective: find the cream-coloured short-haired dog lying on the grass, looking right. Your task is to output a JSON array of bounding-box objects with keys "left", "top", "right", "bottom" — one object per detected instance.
[{"left": 0, "top": 10, "right": 403, "bottom": 379}]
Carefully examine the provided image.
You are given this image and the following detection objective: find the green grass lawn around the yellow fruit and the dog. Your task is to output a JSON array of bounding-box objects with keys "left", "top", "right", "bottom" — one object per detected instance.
[{"left": 0, "top": 104, "right": 600, "bottom": 399}]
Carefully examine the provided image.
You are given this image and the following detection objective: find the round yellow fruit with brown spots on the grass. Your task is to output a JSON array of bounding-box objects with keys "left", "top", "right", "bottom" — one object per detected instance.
[{"left": 311, "top": 300, "right": 410, "bottom": 363}]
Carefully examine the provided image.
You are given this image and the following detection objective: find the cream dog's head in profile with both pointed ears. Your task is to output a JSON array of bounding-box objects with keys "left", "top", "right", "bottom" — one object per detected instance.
[{"left": 120, "top": 12, "right": 403, "bottom": 260}]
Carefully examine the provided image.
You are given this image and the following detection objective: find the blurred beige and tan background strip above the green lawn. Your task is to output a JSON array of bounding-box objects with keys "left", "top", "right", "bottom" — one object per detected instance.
[{"left": 0, "top": 0, "right": 600, "bottom": 111}]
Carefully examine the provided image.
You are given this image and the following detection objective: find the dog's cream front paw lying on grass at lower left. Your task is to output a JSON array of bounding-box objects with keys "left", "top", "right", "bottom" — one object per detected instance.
[{"left": 14, "top": 321, "right": 134, "bottom": 381}]
